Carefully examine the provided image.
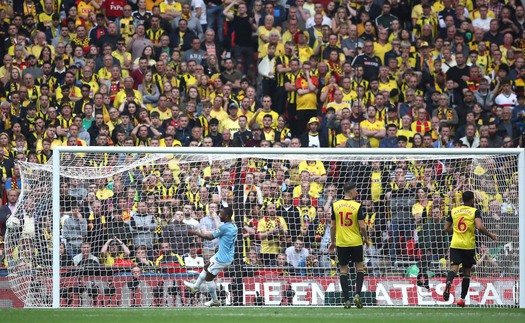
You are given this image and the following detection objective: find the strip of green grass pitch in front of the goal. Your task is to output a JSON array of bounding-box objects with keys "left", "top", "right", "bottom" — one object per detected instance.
[{"left": 0, "top": 307, "right": 525, "bottom": 323}]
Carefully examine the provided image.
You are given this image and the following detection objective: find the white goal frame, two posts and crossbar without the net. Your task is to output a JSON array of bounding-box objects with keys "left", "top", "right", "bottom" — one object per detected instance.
[{"left": 52, "top": 146, "right": 525, "bottom": 308}]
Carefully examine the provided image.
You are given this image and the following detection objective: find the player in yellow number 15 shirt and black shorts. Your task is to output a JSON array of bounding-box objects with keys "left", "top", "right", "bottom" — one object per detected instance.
[{"left": 328, "top": 182, "right": 368, "bottom": 308}]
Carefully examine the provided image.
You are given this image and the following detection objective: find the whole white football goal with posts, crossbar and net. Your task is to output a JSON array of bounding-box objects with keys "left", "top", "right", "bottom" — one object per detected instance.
[{"left": 5, "top": 147, "right": 525, "bottom": 308}]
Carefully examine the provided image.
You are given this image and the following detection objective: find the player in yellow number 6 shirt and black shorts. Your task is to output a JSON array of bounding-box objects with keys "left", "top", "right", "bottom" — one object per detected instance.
[{"left": 443, "top": 191, "right": 497, "bottom": 307}]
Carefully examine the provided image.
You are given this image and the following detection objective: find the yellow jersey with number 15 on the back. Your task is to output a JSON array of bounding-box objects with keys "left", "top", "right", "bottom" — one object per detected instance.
[{"left": 332, "top": 200, "right": 365, "bottom": 247}]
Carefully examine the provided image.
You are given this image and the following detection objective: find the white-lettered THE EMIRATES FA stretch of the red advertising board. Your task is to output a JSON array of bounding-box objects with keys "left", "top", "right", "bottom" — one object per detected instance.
[{"left": 239, "top": 277, "right": 517, "bottom": 306}]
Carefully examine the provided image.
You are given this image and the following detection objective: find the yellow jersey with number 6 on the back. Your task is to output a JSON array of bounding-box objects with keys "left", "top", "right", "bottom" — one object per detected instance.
[{"left": 447, "top": 205, "right": 481, "bottom": 250}]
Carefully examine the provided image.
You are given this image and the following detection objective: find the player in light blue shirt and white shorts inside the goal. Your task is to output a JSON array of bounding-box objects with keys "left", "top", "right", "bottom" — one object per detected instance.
[{"left": 184, "top": 207, "right": 237, "bottom": 306}]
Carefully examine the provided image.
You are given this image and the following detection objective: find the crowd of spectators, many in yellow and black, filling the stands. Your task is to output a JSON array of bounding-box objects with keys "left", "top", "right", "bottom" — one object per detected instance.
[{"left": 0, "top": 0, "right": 525, "bottom": 282}]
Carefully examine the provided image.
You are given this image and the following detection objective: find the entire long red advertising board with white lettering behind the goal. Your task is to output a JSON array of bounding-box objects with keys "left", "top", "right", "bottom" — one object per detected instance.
[{"left": 0, "top": 275, "right": 518, "bottom": 307}]
